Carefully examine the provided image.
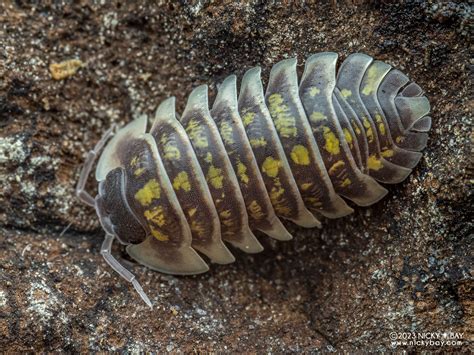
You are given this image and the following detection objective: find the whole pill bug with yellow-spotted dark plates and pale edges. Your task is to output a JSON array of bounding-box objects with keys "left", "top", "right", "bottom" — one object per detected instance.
[{"left": 76, "top": 52, "right": 431, "bottom": 306}]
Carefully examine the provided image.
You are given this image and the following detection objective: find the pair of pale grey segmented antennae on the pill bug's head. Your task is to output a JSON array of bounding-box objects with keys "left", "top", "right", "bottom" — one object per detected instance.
[{"left": 76, "top": 126, "right": 153, "bottom": 308}]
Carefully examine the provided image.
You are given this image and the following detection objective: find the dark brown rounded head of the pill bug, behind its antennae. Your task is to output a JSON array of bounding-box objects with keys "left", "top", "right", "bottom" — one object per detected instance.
[{"left": 98, "top": 168, "right": 146, "bottom": 244}]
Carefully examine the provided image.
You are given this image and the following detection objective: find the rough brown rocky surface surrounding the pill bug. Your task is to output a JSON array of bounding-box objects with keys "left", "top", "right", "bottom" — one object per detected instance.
[{"left": 0, "top": 1, "right": 474, "bottom": 352}]
